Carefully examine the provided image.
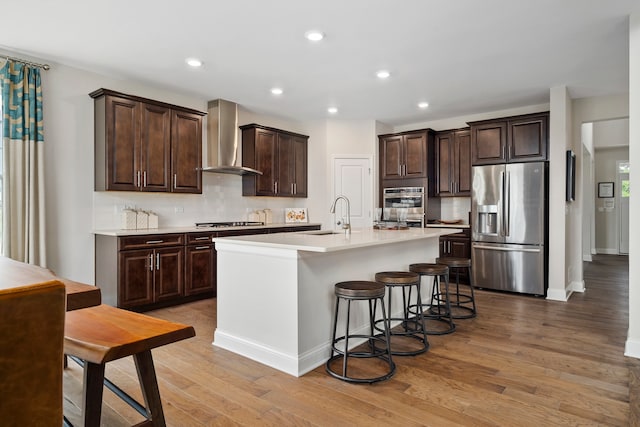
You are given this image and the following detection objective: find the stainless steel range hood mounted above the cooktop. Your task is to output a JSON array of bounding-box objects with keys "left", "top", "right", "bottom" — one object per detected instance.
[{"left": 202, "top": 99, "right": 262, "bottom": 175}]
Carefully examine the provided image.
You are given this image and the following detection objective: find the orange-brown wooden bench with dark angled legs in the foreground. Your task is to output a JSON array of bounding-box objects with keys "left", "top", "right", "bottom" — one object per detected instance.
[{"left": 64, "top": 304, "right": 195, "bottom": 427}]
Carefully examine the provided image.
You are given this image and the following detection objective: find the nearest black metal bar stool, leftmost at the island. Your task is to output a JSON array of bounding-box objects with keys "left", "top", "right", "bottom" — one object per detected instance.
[{"left": 325, "top": 281, "right": 396, "bottom": 383}]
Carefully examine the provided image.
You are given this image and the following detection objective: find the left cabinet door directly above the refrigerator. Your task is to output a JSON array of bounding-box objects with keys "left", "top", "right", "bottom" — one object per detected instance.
[{"left": 471, "top": 121, "right": 507, "bottom": 165}]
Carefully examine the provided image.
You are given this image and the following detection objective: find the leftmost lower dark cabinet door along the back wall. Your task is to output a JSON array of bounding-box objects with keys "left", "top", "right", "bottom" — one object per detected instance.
[{"left": 118, "top": 249, "right": 155, "bottom": 308}]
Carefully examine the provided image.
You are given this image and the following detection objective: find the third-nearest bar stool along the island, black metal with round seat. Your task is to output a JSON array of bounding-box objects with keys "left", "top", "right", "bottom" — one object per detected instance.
[{"left": 409, "top": 263, "right": 456, "bottom": 335}]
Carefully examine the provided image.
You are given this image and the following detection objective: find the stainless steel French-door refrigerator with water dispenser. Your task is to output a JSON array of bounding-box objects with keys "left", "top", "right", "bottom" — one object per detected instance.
[{"left": 471, "top": 162, "right": 548, "bottom": 295}]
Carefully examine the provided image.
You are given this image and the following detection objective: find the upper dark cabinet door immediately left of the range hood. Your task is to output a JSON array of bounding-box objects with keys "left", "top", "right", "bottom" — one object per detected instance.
[{"left": 171, "top": 110, "right": 202, "bottom": 194}]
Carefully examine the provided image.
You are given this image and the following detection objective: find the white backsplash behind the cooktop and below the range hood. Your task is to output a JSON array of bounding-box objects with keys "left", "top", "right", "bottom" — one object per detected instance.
[{"left": 93, "top": 173, "right": 308, "bottom": 230}]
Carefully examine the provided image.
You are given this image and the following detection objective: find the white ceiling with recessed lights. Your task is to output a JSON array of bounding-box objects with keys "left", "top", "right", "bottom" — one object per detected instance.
[{"left": 0, "top": 0, "right": 640, "bottom": 125}]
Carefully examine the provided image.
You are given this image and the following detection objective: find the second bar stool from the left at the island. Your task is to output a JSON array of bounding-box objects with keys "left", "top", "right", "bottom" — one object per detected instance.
[{"left": 376, "top": 271, "right": 429, "bottom": 356}]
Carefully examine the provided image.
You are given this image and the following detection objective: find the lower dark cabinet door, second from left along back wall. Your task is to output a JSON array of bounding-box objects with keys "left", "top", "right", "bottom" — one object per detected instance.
[{"left": 153, "top": 247, "right": 184, "bottom": 301}]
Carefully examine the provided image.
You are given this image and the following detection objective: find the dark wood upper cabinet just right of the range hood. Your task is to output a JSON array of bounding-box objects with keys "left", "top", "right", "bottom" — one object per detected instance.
[{"left": 240, "top": 124, "right": 309, "bottom": 197}]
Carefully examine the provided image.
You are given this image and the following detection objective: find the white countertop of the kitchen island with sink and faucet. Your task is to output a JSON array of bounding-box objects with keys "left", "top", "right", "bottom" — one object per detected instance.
[{"left": 213, "top": 228, "right": 460, "bottom": 252}]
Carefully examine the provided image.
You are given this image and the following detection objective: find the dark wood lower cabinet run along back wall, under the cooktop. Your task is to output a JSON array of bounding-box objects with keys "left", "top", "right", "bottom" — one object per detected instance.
[{"left": 96, "top": 225, "right": 320, "bottom": 311}]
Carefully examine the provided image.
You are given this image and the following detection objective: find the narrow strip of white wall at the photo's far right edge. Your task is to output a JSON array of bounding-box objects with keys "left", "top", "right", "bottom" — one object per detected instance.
[{"left": 624, "top": 11, "right": 640, "bottom": 358}]
